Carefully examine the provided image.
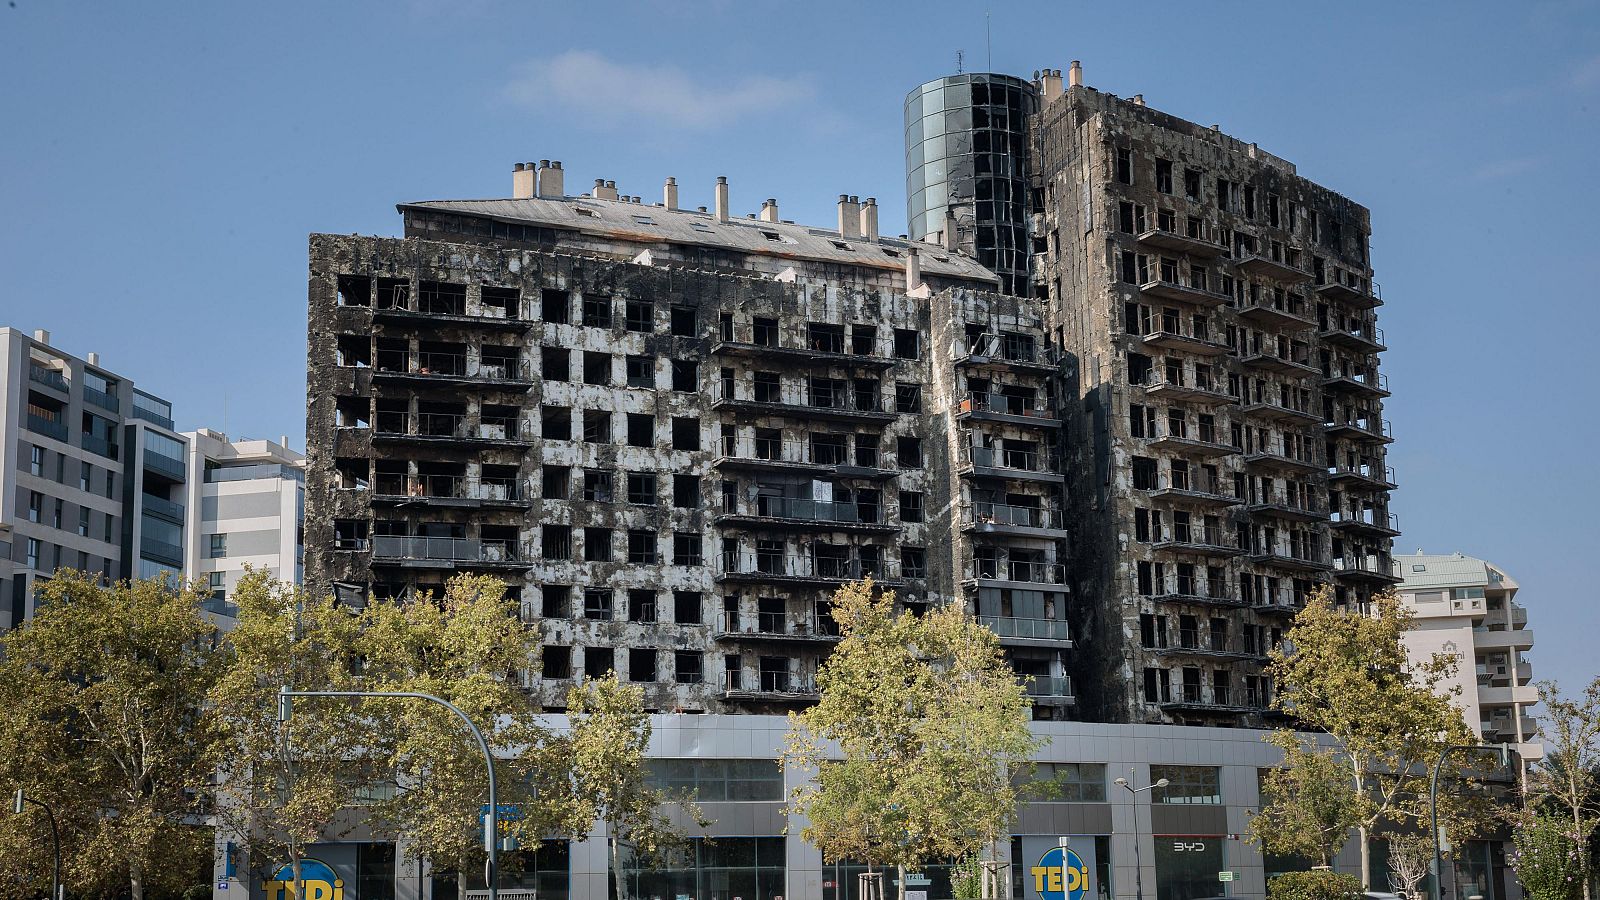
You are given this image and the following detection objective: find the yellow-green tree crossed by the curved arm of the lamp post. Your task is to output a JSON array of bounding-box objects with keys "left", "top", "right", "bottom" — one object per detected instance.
[{"left": 358, "top": 575, "right": 576, "bottom": 889}]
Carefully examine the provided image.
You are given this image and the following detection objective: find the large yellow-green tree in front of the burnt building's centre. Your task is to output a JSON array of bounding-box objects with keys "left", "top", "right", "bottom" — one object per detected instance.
[{"left": 781, "top": 581, "right": 1038, "bottom": 894}]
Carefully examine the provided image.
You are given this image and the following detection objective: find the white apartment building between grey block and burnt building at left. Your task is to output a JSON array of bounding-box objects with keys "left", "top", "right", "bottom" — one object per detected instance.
[{"left": 184, "top": 428, "right": 306, "bottom": 618}]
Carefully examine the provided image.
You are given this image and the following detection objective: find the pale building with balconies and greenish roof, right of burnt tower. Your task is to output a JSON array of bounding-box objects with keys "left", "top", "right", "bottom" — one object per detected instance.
[{"left": 1394, "top": 549, "right": 1544, "bottom": 762}]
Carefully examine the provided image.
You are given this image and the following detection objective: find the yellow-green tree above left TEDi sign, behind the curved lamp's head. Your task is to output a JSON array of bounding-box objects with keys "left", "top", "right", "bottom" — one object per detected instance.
[{"left": 210, "top": 570, "right": 368, "bottom": 881}]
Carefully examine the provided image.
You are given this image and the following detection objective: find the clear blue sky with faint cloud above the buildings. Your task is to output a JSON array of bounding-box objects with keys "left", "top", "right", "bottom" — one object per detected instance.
[{"left": 0, "top": 0, "right": 1600, "bottom": 687}]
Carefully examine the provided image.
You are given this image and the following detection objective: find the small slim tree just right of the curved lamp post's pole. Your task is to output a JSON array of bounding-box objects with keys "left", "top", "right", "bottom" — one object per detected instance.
[{"left": 566, "top": 673, "right": 709, "bottom": 900}]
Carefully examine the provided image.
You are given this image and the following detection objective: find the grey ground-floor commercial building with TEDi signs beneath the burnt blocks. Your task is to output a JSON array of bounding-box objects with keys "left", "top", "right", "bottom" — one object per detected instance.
[{"left": 213, "top": 714, "right": 1522, "bottom": 900}]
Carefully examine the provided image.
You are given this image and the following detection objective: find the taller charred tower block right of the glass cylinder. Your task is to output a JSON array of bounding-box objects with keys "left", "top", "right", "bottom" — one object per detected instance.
[{"left": 1032, "top": 75, "right": 1398, "bottom": 725}]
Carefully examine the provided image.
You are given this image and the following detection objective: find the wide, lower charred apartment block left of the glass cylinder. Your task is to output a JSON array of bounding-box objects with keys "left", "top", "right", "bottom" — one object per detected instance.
[{"left": 306, "top": 163, "right": 1074, "bottom": 719}]
